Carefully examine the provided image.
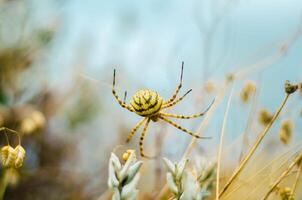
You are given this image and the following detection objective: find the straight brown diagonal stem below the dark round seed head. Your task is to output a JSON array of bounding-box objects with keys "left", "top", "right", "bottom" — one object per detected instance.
[{"left": 219, "top": 93, "right": 290, "bottom": 197}]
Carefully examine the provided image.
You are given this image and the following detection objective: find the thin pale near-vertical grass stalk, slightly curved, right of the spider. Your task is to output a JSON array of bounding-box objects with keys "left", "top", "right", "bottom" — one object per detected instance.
[{"left": 216, "top": 87, "right": 234, "bottom": 200}]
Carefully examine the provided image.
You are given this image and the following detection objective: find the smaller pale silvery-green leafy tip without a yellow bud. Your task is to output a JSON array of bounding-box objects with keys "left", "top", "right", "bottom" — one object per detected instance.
[{"left": 163, "top": 158, "right": 188, "bottom": 200}]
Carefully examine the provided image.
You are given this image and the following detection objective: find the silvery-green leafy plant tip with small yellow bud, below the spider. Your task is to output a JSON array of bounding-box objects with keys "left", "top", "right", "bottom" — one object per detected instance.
[{"left": 108, "top": 150, "right": 143, "bottom": 200}]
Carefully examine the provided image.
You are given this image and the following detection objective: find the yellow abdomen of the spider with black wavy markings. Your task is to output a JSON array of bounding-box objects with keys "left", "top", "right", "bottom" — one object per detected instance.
[{"left": 130, "top": 89, "right": 163, "bottom": 116}]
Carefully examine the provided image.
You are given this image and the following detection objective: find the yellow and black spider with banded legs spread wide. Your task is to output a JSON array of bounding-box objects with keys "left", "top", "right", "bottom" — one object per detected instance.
[{"left": 112, "top": 62, "right": 214, "bottom": 158}]
